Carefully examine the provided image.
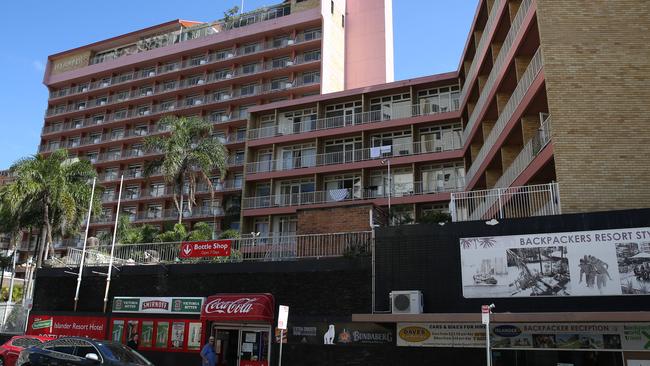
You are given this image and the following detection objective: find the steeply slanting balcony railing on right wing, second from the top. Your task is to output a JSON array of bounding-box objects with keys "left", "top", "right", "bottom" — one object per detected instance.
[{"left": 463, "top": 0, "right": 532, "bottom": 141}]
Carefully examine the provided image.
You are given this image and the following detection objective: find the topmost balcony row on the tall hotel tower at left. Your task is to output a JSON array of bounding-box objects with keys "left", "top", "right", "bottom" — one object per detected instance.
[{"left": 45, "top": 25, "right": 322, "bottom": 100}]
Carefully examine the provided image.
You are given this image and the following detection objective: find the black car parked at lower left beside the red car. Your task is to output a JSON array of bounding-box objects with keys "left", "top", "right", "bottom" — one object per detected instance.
[{"left": 16, "top": 337, "right": 153, "bottom": 366}]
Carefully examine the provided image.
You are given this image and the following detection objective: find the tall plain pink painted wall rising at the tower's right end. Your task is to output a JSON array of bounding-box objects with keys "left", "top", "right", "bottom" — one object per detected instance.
[{"left": 345, "top": 0, "right": 394, "bottom": 89}]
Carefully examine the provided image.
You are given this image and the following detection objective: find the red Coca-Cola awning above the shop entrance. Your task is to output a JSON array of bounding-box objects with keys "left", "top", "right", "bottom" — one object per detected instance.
[{"left": 201, "top": 294, "right": 275, "bottom": 323}]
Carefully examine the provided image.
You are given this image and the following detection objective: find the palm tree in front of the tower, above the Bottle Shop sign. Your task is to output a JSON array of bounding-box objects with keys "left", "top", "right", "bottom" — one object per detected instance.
[{"left": 144, "top": 116, "right": 228, "bottom": 224}]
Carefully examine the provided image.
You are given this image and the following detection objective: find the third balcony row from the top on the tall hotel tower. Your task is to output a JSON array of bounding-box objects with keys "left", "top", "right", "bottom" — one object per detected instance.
[{"left": 43, "top": 77, "right": 320, "bottom": 135}]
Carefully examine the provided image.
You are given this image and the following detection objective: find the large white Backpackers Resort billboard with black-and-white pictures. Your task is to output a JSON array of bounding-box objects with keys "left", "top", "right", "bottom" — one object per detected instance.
[{"left": 460, "top": 227, "right": 650, "bottom": 298}]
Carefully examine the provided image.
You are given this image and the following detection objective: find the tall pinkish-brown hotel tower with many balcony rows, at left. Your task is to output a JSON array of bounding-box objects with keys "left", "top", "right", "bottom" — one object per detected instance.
[{"left": 39, "top": 0, "right": 393, "bottom": 240}]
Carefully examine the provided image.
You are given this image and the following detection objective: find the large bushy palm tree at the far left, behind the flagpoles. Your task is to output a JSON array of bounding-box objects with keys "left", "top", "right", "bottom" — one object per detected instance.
[{"left": 3, "top": 150, "right": 101, "bottom": 267}]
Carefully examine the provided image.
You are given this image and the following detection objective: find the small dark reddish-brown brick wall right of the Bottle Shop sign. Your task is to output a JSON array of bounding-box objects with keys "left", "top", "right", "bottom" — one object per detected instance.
[{"left": 297, "top": 204, "right": 373, "bottom": 234}]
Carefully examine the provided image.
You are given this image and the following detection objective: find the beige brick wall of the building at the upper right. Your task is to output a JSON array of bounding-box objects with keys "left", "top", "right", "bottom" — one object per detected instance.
[{"left": 537, "top": 0, "right": 650, "bottom": 213}]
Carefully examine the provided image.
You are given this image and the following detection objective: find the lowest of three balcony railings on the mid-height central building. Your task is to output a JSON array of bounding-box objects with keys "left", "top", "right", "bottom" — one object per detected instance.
[{"left": 242, "top": 178, "right": 464, "bottom": 209}]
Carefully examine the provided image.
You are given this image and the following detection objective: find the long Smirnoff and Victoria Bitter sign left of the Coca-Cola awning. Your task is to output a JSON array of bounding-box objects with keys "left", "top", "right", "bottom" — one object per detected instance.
[{"left": 113, "top": 297, "right": 204, "bottom": 314}]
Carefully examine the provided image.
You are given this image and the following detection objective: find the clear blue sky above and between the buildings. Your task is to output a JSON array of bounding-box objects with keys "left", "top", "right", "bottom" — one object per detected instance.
[{"left": 0, "top": 0, "right": 478, "bottom": 170}]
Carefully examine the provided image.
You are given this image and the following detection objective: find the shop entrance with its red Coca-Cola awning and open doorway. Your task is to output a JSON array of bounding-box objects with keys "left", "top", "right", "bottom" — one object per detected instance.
[{"left": 201, "top": 294, "right": 275, "bottom": 366}]
